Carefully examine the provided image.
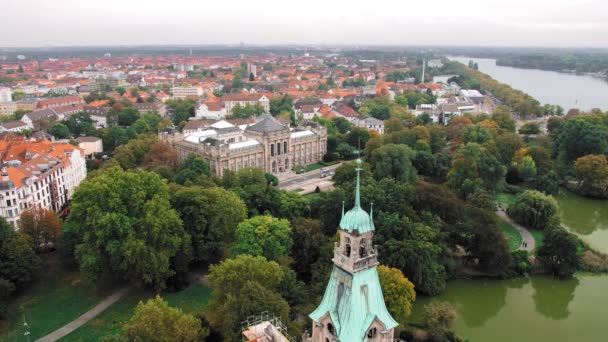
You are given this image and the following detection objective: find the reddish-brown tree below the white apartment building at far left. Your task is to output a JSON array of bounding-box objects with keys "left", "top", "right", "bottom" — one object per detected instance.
[{"left": 19, "top": 207, "right": 61, "bottom": 253}]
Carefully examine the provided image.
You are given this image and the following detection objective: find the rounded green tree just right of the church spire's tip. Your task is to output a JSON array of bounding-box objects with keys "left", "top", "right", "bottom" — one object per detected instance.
[{"left": 369, "top": 144, "right": 416, "bottom": 183}]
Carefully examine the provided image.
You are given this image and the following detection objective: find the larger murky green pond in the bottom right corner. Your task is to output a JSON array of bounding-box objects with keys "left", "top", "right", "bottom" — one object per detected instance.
[{"left": 411, "top": 274, "right": 608, "bottom": 342}]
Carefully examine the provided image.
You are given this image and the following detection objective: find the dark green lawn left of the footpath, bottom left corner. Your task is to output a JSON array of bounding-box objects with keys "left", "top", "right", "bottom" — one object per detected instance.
[{"left": 0, "top": 253, "right": 119, "bottom": 341}]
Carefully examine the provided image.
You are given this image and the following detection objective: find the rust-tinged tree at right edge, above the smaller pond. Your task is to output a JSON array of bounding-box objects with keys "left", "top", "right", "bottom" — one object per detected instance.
[{"left": 574, "top": 154, "right": 608, "bottom": 198}]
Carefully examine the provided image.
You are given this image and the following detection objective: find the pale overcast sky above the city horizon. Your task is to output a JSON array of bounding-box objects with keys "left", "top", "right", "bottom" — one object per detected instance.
[{"left": 0, "top": 0, "right": 608, "bottom": 47}]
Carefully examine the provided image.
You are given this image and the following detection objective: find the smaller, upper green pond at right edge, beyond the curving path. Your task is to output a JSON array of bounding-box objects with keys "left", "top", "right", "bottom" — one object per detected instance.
[{"left": 555, "top": 190, "right": 608, "bottom": 253}]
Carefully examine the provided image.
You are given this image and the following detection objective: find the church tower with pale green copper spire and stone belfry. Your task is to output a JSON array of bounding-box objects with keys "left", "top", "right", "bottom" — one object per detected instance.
[{"left": 308, "top": 159, "right": 398, "bottom": 342}]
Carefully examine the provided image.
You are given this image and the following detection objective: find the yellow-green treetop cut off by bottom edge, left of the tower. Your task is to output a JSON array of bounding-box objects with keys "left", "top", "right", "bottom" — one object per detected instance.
[{"left": 123, "top": 295, "right": 209, "bottom": 342}]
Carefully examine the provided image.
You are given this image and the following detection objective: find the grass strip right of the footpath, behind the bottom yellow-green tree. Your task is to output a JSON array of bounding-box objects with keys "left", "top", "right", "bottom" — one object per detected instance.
[{"left": 61, "top": 282, "right": 211, "bottom": 341}]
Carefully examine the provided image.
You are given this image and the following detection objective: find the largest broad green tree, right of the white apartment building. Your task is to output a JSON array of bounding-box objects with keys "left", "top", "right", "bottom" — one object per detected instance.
[{"left": 69, "top": 168, "right": 190, "bottom": 289}]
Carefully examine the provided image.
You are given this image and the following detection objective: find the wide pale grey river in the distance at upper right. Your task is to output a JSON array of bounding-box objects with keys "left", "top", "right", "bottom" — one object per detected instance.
[{"left": 449, "top": 57, "right": 608, "bottom": 111}]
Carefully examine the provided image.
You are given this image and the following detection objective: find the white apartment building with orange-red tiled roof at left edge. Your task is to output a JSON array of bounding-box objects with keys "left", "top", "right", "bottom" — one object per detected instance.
[{"left": 0, "top": 138, "right": 87, "bottom": 229}]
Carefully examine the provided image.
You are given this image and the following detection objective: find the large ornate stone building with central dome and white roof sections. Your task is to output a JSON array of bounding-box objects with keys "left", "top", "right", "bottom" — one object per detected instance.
[{"left": 160, "top": 114, "right": 327, "bottom": 177}]
